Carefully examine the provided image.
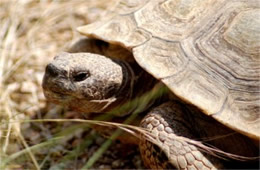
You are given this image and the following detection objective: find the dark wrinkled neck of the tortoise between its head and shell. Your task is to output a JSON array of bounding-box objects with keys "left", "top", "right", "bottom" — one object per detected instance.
[{"left": 103, "top": 60, "right": 158, "bottom": 116}]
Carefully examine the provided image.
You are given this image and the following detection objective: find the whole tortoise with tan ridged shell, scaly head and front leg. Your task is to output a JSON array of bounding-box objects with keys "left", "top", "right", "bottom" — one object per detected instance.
[{"left": 43, "top": 0, "right": 260, "bottom": 169}]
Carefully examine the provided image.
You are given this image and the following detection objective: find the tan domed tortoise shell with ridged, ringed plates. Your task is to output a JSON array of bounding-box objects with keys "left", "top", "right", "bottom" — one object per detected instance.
[{"left": 79, "top": 0, "right": 260, "bottom": 140}]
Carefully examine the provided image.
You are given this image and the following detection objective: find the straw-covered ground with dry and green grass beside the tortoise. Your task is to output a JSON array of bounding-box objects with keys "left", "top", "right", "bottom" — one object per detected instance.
[{"left": 0, "top": 0, "right": 144, "bottom": 169}]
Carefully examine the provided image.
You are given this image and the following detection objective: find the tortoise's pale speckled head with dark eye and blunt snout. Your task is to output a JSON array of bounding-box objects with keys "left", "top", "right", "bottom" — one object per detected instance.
[{"left": 42, "top": 52, "right": 132, "bottom": 112}]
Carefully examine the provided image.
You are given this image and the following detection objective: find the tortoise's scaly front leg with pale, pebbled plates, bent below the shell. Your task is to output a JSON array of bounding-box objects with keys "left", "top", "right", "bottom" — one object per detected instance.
[{"left": 139, "top": 102, "right": 222, "bottom": 169}]
